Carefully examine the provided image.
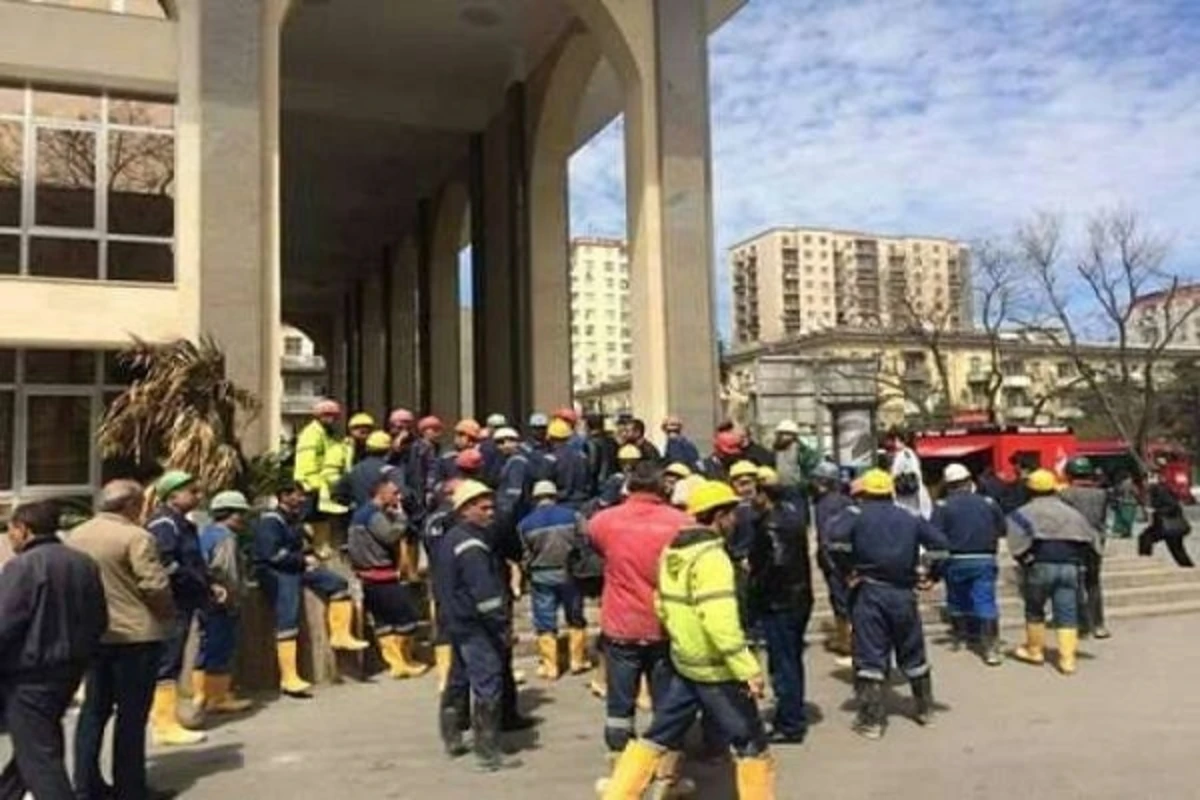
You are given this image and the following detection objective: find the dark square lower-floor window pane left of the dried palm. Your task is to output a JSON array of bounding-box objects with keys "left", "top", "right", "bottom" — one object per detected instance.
[{"left": 25, "top": 395, "right": 92, "bottom": 486}]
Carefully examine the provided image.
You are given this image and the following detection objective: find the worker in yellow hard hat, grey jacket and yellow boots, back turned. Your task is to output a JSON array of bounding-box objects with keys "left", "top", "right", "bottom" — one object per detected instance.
[{"left": 1007, "top": 469, "right": 1103, "bottom": 675}]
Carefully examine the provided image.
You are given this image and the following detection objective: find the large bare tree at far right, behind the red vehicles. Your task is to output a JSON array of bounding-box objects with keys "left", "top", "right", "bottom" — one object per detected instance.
[{"left": 1016, "top": 210, "right": 1200, "bottom": 458}]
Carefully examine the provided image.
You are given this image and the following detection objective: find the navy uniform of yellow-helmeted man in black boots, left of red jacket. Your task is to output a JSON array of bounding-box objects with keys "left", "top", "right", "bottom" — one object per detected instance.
[{"left": 431, "top": 522, "right": 510, "bottom": 709}]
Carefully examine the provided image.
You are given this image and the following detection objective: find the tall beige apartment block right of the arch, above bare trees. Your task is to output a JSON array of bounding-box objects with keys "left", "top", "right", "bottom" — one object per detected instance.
[{"left": 730, "top": 228, "right": 971, "bottom": 343}]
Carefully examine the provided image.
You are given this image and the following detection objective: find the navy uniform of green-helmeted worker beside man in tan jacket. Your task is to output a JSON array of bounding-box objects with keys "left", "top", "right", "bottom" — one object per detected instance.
[{"left": 146, "top": 505, "right": 211, "bottom": 681}]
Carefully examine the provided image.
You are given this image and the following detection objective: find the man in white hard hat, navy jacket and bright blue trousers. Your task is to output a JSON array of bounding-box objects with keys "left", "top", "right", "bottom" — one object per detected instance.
[{"left": 932, "top": 464, "right": 1006, "bottom": 667}]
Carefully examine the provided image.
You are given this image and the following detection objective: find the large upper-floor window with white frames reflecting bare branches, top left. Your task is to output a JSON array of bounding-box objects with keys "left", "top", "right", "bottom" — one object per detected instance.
[{"left": 0, "top": 86, "right": 175, "bottom": 283}]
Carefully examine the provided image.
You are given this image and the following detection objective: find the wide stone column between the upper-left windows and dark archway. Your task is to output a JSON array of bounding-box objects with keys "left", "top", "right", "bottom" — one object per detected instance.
[{"left": 178, "top": 0, "right": 288, "bottom": 452}]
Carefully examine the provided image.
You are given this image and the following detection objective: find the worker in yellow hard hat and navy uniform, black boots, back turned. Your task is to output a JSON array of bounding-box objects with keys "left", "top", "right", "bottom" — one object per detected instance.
[{"left": 828, "top": 469, "right": 949, "bottom": 739}]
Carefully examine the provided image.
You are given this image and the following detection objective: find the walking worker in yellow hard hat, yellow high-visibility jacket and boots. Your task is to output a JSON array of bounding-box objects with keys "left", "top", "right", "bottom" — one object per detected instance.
[{"left": 604, "top": 481, "right": 775, "bottom": 800}]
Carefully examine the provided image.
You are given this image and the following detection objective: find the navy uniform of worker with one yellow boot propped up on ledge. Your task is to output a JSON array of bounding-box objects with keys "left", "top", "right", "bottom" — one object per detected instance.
[{"left": 254, "top": 510, "right": 350, "bottom": 642}]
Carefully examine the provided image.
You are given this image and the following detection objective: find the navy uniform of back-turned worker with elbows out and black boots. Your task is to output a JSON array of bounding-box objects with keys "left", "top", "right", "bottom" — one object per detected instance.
[{"left": 829, "top": 497, "right": 947, "bottom": 684}]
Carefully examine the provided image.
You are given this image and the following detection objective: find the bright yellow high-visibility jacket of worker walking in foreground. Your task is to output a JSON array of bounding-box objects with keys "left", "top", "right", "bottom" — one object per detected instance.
[{"left": 654, "top": 528, "right": 761, "bottom": 684}]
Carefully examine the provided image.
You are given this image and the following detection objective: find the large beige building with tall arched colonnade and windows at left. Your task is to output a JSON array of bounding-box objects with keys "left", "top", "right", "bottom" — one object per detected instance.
[{"left": 0, "top": 0, "right": 742, "bottom": 503}]
